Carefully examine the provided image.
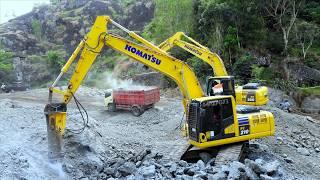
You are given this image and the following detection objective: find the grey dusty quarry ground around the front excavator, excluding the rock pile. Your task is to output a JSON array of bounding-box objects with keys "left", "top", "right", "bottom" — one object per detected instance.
[{"left": 0, "top": 87, "right": 320, "bottom": 179}]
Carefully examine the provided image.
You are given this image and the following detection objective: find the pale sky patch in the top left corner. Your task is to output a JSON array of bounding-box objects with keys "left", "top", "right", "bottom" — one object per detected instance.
[{"left": 0, "top": 0, "right": 49, "bottom": 24}]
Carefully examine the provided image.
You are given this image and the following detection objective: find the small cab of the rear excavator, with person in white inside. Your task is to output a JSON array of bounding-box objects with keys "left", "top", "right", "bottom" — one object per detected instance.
[{"left": 206, "top": 76, "right": 236, "bottom": 98}]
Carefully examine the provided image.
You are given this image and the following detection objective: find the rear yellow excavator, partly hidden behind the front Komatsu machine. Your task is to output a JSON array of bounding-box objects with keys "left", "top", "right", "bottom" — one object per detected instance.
[{"left": 158, "top": 32, "right": 269, "bottom": 106}]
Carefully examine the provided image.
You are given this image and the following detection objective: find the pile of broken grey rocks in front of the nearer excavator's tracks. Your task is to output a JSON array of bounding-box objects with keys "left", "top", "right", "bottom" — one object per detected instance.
[{"left": 65, "top": 150, "right": 283, "bottom": 180}]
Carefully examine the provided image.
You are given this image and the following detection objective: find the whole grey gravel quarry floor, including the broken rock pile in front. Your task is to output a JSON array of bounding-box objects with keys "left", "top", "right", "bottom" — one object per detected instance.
[{"left": 0, "top": 88, "right": 320, "bottom": 179}]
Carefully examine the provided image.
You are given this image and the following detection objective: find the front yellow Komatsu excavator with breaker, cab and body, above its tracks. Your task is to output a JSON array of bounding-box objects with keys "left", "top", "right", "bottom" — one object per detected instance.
[{"left": 44, "top": 16, "right": 275, "bottom": 161}]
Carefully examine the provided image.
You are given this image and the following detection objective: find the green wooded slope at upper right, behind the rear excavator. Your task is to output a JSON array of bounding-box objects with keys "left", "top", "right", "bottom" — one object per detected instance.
[{"left": 144, "top": 0, "right": 320, "bottom": 89}]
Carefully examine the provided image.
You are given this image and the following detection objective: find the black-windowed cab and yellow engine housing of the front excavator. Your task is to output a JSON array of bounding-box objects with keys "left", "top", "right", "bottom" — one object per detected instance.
[{"left": 187, "top": 95, "right": 274, "bottom": 148}]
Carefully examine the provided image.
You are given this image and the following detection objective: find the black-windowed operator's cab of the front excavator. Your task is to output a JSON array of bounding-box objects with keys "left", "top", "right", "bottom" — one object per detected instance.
[{"left": 188, "top": 96, "right": 235, "bottom": 142}]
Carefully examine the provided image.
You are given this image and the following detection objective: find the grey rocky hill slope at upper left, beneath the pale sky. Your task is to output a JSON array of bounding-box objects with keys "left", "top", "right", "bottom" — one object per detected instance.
[{"left": 0, "top": 0, "right": 154, "bottom": 86}]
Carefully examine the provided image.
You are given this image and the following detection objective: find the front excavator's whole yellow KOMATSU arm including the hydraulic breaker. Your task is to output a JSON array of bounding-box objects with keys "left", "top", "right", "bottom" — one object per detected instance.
[{"left": 45, "top": 16, "right": 205, "bottom": 157}]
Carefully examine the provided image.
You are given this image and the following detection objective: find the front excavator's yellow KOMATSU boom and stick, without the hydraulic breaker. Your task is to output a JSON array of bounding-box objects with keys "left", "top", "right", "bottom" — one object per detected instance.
[{"left": 50, "top": 16, "right": 204, "bottom": 107}]
